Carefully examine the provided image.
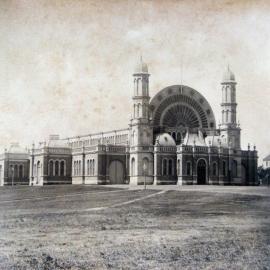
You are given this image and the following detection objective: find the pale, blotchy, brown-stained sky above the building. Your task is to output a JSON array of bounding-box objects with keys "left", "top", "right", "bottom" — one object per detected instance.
[{"left": 0, "top": 0, "right": 270, "bottom": 162}]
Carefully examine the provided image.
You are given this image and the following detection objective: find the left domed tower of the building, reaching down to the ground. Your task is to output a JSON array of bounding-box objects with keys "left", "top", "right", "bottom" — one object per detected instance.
[{"left": 130, "top": 57, "right": 153, "bottom": 184}]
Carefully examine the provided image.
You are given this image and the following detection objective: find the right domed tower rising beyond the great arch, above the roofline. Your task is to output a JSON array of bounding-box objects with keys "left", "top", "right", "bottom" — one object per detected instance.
[{"left": 220, "top": 66, "right": 241, "bottom": 149}]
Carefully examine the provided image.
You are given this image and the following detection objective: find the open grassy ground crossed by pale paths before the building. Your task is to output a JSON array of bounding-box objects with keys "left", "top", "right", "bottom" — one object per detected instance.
[{"left": 0, "top": 186, "right": 270, "bottom": 270}]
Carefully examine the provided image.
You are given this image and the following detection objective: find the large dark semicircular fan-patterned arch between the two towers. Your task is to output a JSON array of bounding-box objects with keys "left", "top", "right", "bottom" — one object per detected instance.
[{"left": 150, "top": 85, "right": 216, "bottom": 142}]
